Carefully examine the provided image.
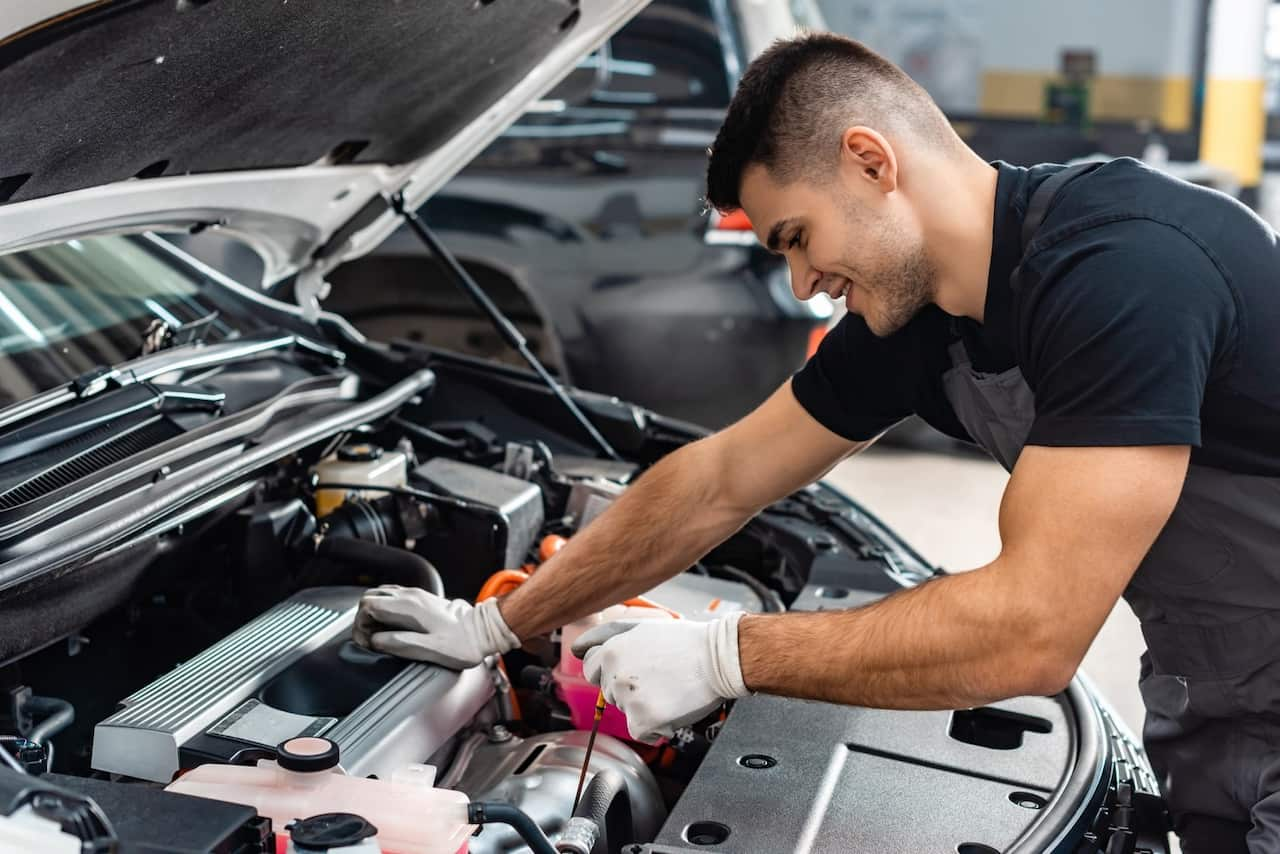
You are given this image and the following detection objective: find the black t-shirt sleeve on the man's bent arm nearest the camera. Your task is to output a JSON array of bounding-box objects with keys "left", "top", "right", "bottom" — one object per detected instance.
[{"left": 1018, "top": 220, "right": 1235, "bottom": 447}]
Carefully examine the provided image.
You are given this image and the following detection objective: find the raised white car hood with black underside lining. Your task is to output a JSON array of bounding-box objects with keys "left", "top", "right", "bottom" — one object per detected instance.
[{"left": 0, "top": 0, "right": 648, "bottom": 283}]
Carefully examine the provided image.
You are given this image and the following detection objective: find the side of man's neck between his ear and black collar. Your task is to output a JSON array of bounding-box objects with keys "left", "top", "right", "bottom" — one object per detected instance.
[{"left": 925, "top": 151, "right": 998, "bottom": 323}]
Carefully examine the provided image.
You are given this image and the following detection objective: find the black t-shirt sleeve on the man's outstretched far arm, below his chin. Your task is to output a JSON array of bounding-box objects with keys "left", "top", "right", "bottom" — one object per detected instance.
[{"left": 791, "top": 314, "right": 922, "bottom": 442}]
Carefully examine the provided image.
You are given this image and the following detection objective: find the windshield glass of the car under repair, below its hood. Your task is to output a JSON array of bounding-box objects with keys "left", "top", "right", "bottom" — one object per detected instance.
[{"left": 0, "top": 236, "right": 257, "bottom": 406}]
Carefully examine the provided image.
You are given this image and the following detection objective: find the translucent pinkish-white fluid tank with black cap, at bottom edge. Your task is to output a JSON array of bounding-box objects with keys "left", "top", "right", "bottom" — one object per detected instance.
[{"left": 166, "top": 737, "right": 475, "bottom": 854}]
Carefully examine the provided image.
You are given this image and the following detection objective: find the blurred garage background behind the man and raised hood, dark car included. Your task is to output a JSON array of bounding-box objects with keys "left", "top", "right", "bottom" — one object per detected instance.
[{"left": 175, "top": 0, "right": 1280, "bottom": 730}]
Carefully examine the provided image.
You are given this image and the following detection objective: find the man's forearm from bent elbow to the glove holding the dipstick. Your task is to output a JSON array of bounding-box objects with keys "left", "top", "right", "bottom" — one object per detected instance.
[{"left": 739, "top": 563, "right": 1075, "bottom": 709}]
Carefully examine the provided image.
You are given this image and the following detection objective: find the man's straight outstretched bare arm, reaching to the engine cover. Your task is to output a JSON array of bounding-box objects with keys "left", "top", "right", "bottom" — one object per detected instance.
[{"left": 499, "top": 383, "right": 870, "bottom": 638}]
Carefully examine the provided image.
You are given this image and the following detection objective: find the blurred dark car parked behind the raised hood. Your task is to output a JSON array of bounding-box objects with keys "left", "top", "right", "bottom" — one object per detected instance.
[{"left": 325, "top": 0, "right": 832, "bottom": 426}]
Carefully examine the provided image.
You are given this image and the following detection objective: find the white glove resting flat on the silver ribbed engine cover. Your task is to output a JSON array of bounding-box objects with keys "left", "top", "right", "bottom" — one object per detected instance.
[{"left": 351, "top": 584, "right": 520, "bottom": 670}]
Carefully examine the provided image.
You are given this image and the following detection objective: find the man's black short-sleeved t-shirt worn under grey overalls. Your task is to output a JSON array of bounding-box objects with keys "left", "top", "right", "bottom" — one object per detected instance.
[{"left": 792, "top": 157, "right": 1280, "bottom": 476}]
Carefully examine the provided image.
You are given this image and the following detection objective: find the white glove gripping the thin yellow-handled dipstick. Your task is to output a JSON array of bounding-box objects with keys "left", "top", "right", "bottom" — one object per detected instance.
[{"left": 573, "top": 611, "right": 749, "bottom": 743}]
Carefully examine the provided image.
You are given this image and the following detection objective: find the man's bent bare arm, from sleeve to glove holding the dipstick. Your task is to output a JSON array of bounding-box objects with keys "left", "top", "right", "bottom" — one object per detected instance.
[{"left": 737, "top": 446, "right": 1190, "bottom": 709}]
